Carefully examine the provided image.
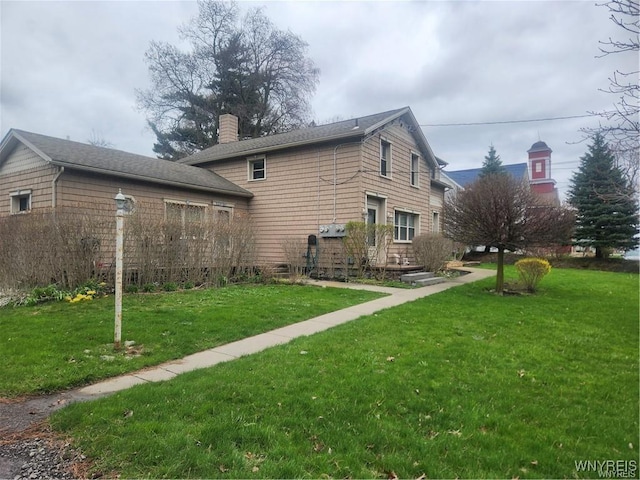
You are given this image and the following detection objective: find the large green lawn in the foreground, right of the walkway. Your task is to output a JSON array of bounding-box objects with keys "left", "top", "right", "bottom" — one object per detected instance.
[{"left": 52, "top": 267, "right": 639, "bottom": 478}]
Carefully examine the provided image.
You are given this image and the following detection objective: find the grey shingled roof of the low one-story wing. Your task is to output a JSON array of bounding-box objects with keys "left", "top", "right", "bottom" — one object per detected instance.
[{"left": 0, "top": 129, "right": 253, "bottom": 197}]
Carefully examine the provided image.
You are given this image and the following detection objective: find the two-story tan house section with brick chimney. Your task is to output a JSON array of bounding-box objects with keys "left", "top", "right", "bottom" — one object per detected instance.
[{"left": 180, "top": 107, "right": 449, "bottom": 263}]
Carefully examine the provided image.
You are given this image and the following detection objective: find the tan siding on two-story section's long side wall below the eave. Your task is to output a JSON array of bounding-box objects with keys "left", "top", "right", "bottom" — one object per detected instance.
[{"left": 209, "top": 142, "right": 363, "bottom": 263}]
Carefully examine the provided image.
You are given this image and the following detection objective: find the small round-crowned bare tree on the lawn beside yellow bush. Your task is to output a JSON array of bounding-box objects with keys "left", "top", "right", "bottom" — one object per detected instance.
[{"left": 443, "top": 174, "right": 575, "bottom": 294}]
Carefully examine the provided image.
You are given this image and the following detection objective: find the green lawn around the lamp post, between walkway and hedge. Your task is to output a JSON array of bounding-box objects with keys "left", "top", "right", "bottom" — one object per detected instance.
[{"left": 0, "top": 285, "right": 381, "bottom": 397}]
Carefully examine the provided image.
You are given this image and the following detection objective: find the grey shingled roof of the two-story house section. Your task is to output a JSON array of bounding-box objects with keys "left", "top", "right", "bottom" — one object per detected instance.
[{"left": 178, "top": 107, "right": 439, "bottom": 165}]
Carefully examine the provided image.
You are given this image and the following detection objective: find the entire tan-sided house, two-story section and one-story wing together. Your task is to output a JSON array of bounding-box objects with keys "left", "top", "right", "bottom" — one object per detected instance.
[{"left": 0, "top": 107, "right": 448, "bottom": 270}]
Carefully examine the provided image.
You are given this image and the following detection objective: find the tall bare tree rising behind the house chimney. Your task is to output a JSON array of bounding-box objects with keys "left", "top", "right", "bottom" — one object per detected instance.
[{"left": 137, "top": 0, "right": 319, "bottom": 159}]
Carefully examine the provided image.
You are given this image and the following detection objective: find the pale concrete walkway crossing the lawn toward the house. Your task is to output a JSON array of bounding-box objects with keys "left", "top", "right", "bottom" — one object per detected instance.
[{"left": 76, "top": 267, "right": 495, "bottom": 400}]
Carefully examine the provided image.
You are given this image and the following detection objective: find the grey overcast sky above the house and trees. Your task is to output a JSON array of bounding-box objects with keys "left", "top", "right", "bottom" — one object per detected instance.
[{"left": 0, "top": 0, "right": 639, "bottom": 199}]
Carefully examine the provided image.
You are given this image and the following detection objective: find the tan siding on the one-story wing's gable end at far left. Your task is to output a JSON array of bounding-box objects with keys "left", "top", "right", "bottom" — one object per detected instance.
[{"left": 0, "top": 146, "right": 58, "bottom": 217}]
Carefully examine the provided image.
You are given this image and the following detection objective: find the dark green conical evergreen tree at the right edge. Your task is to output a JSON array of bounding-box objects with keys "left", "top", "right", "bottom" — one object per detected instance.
[{"left": 569, "top": 133, "right": 638, "bottom": 258}]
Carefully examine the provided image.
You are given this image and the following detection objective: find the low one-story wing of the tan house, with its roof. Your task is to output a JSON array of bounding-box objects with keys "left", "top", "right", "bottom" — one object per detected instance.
[{"left": 0, "top": 129, "right": 252, "bottom": 217}]
